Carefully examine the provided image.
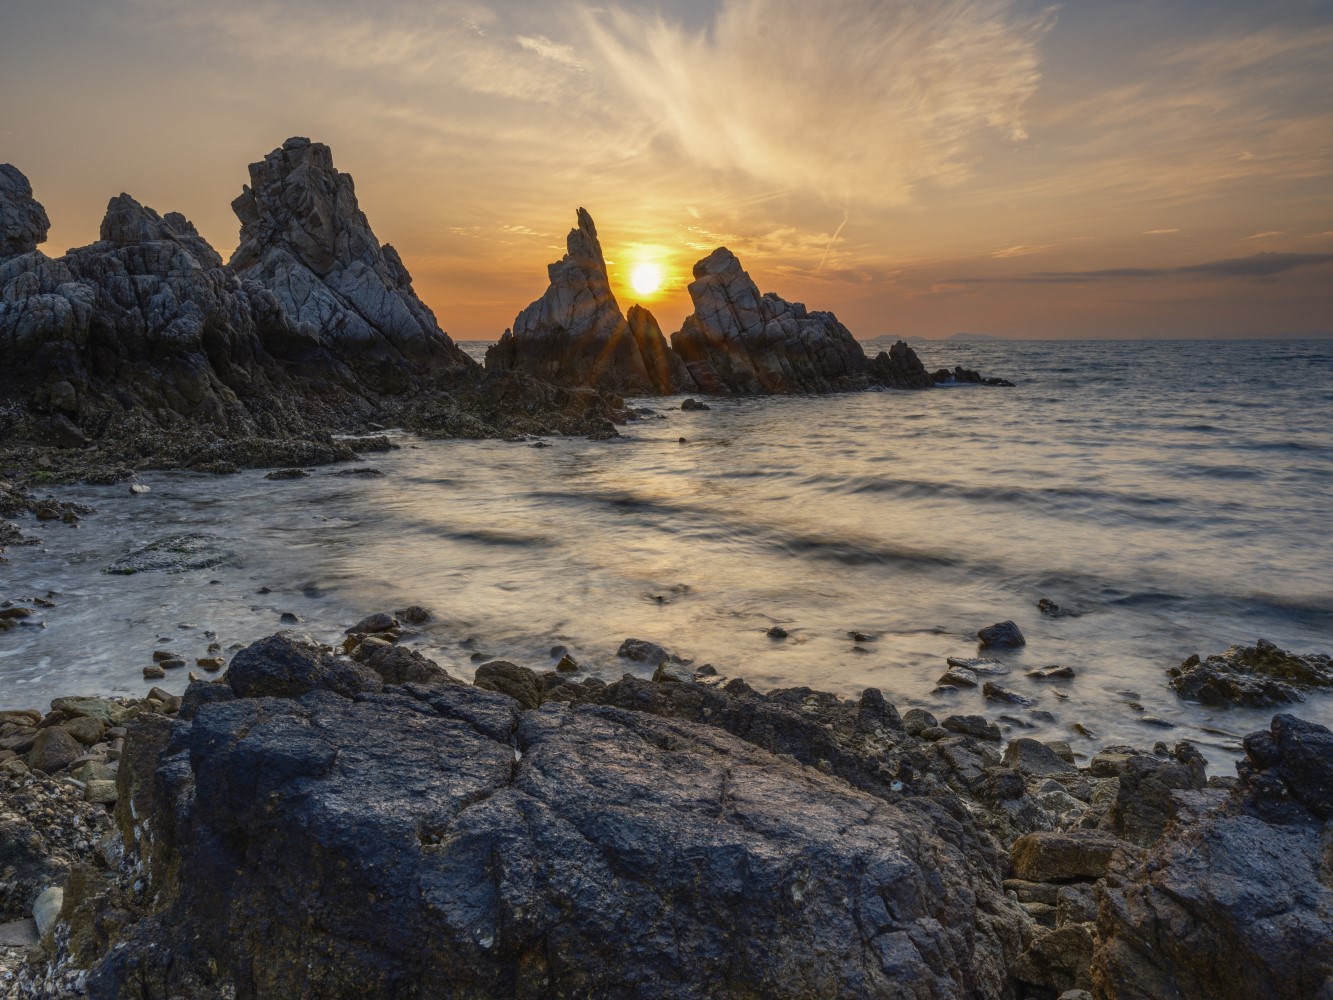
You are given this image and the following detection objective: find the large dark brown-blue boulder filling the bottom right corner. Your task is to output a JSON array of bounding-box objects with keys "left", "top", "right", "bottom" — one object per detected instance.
[{"left": 1092, "top": 715, "right": 1333, "bottom": 1000}]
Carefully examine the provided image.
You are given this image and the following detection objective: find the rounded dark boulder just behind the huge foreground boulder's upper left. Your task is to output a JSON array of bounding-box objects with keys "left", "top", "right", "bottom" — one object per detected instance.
[{"left": 227, "top": 635, "right": 384, "bottom": 699}]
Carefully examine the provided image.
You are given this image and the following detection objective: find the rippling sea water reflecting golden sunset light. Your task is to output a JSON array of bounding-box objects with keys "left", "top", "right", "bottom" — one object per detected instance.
[{"left": 0, "top": 341, "right": 1333, "bottom": 771}]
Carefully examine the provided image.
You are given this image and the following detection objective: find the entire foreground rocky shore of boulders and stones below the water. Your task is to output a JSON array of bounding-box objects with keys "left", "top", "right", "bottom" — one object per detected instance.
[{"left": 0, "top": 608, "right": 1333, "bottom": 1000}]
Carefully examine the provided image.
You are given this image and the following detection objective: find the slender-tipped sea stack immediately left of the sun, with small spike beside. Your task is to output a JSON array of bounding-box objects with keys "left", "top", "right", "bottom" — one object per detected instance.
[{"left": 487, "top": 208, "right": 688, "bottom": 396}]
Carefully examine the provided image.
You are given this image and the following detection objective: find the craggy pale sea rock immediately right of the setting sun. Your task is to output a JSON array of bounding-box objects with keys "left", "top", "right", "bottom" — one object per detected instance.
[{"left": 672, "top": 247, "right": 870, "bottom": 395}]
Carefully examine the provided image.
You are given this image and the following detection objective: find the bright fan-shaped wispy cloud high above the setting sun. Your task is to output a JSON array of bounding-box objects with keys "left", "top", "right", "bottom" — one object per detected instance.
[{"left": 585, "top": 0, "right": 1052, "bottom": 207}]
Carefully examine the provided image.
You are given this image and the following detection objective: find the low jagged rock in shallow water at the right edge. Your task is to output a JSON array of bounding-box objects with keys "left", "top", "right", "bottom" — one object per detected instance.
[{"left": 1168, "top": 639, "right": 1333, "bottom": 708}]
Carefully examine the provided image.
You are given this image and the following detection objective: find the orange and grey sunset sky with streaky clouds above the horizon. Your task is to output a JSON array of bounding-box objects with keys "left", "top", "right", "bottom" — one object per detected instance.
[{"left": 0, "top": 0, "right": 1333, "bottom": 340}]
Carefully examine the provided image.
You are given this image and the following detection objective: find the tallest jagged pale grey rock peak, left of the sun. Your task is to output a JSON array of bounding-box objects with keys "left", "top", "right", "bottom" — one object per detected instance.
[{"left": 228, "top": 137, "right": 475, "bottom": 392}]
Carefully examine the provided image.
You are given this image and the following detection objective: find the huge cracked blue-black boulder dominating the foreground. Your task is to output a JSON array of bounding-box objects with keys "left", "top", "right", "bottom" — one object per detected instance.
[{"left": 88, "top": 669, "right": 1017, "bottom": 997}]
